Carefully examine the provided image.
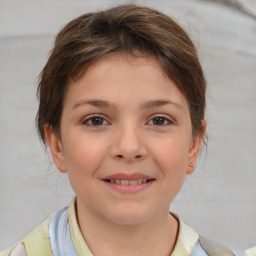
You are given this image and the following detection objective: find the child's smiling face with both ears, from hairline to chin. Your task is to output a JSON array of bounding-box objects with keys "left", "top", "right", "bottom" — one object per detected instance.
[{"left": 46, "top": 55, "right": 202, "bottom": 224}]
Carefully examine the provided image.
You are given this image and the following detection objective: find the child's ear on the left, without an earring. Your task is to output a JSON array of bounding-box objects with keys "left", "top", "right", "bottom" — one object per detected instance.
[{"left": 44, "top": 124, "right": 67, "bottom": 173}]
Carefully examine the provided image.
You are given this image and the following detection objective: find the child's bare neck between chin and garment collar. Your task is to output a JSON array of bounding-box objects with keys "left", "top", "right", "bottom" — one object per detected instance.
[{"left": 77, "top": 202, "right": 178, "bottom": 256}]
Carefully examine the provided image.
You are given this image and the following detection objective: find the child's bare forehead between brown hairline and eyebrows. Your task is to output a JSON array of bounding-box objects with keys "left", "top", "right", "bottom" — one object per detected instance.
[{"left": 64, "top": 54, "right": 188, "bottom": 110}]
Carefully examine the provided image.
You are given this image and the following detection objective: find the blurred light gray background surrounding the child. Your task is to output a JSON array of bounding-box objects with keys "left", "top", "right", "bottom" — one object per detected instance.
[{"left": 0, "top": 0, "right": 256, "bottom": 254}]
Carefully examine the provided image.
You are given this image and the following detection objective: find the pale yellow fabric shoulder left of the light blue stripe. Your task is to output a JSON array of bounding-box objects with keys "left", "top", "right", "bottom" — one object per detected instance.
[{"left": 0, "top": 219, "right": 53, "bottom": 256}]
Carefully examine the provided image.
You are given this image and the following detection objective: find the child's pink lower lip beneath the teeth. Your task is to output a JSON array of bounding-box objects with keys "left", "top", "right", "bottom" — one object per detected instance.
[{"left": 104, "top": 180, "right": 154, "bottom": 194}]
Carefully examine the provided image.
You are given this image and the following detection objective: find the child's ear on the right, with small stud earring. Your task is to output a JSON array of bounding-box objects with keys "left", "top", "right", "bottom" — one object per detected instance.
[{"left": 186, "top": 120, "right": 206, "bottom": 174}]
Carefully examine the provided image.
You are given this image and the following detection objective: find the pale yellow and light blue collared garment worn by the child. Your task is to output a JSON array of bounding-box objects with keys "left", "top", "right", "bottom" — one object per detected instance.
[{"left": 0, "top": 200, "right": 233, "bottom": 256}]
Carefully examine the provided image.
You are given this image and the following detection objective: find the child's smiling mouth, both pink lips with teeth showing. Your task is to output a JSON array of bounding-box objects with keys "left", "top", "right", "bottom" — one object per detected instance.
[{"left": 103, "top": 173, "right": 155, "bottom": 193}]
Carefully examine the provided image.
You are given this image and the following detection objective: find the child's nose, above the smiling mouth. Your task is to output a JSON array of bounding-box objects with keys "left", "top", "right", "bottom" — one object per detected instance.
[{"left": 110, "top": 125, "right": 148, "bottom": 162}]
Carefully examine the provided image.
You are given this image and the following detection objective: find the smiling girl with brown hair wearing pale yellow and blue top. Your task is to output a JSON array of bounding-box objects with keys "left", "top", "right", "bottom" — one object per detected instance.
[{"left": 1, "top": 5, "right": 233, "bottom": 256}]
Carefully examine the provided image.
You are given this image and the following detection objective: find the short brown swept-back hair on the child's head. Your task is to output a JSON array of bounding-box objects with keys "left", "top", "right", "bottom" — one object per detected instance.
[{"left": 36, "top": 5, "right": 206, "bottom": 143}]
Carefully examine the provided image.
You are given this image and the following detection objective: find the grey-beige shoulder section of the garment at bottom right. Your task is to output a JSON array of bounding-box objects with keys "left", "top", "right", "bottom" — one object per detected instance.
[{"left": 199, "top": 236, "right": 235, "bottom": 256}]
